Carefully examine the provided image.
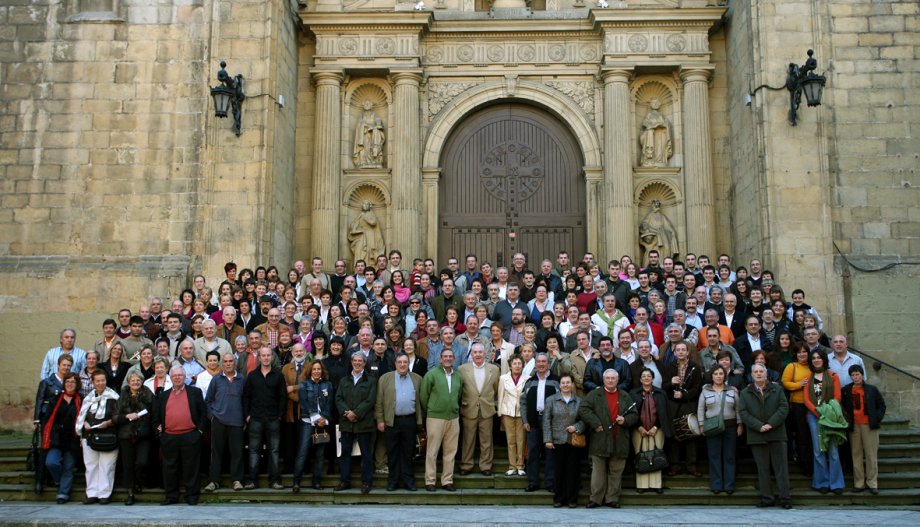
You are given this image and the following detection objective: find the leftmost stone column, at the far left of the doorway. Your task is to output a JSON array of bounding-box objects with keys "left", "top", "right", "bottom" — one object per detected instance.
[{"left": 310, "top": 71, "right": 346, "bottom": 264}]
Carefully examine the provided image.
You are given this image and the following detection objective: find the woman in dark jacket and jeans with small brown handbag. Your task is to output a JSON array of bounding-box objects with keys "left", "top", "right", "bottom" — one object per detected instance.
[{"left": 292, "top": 360, "right": 333, "bottom": 494}]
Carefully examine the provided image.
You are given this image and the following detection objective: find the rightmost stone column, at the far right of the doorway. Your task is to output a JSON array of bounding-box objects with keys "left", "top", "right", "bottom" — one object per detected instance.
[{"left": 680, "top": 69, "right": 716, "bottom": 256}]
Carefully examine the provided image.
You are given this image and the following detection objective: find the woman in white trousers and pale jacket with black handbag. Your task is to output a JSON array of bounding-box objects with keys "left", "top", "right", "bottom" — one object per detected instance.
[{"left": 75, "top": 370, "right": 118, "bottom": 505}]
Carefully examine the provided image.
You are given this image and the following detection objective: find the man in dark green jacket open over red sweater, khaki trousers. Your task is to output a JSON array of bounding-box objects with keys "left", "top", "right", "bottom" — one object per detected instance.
[{"left": 578, "top": 369, "right": 639, "bottom": 509}]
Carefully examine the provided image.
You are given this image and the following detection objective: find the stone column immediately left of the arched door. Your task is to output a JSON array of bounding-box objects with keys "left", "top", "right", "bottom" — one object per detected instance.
[{"left": 387, "top": 71, "right": 423, "bottom": 262}]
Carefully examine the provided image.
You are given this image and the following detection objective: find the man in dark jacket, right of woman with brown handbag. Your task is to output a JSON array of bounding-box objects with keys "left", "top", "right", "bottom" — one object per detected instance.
[{"left": 335, "top": 353, "right": 377, "bottom": 494}]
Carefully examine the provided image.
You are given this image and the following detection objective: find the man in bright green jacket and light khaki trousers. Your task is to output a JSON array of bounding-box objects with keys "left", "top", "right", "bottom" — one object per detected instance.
[{"left": 421, "top": 348, "right": 463, "bottom": 492}]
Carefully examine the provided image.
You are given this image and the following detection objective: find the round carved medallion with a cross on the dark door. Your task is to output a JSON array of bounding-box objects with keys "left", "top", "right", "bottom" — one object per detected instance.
[{"left": 479, "top": 141, "right": 545, "bottom": 201}]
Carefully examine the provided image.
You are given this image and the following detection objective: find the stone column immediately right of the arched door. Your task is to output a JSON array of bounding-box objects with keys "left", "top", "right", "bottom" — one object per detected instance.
[{"left": 604, "top": 69, "right": 638, "bottom": 261}]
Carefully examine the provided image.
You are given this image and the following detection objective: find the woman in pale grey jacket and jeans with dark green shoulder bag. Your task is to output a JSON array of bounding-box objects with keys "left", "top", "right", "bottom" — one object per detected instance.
[{"left": 697, "top": 365, "right": 744, "bottom": 494}]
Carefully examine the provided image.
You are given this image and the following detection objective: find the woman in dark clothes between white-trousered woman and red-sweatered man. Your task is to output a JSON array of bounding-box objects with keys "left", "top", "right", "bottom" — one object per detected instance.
[{"left": 115, "top": 372, "right": 153, "bottom": 505}]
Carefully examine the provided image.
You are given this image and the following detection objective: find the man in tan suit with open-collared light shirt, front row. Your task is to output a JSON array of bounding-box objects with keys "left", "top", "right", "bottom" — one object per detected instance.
[{"left": 457, "top": 342, "right": 501, "bottom": 476}]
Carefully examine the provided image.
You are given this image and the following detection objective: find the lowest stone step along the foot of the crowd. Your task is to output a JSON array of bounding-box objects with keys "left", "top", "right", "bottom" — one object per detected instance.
[{"left": 0, "top": 484, "right": 920, "bottom": 507}]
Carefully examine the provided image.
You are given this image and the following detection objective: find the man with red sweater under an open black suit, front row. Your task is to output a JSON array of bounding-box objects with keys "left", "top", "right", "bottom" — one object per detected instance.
[{"left": 153, "top": 365, "right": 208, "bottom": 505}]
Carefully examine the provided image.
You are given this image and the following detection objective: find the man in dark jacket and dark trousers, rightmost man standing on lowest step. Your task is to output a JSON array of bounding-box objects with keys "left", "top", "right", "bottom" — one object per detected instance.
[{"left": 738, "top": 364, "right": 792, "bottom": 509}]
